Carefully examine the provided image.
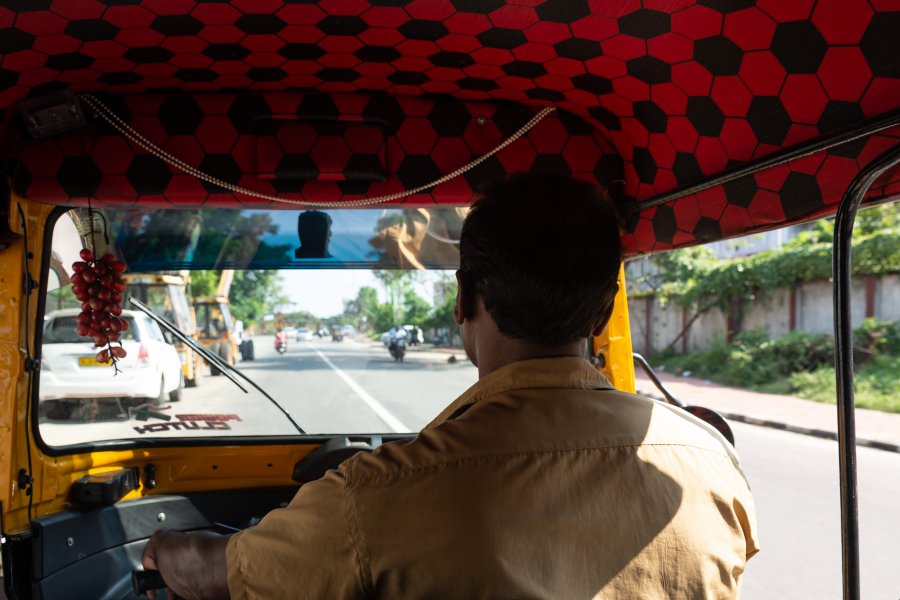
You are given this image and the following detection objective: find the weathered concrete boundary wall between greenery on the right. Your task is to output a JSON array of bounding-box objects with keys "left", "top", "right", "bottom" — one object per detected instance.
[{"left": 628, "top": 275, "right": 900, "bottom": 355}]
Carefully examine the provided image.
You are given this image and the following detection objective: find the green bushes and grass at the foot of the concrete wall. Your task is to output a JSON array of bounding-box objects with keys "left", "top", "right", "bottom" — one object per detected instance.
[{"left": 651, "top": 319, "right": 900, "bottom": 412}]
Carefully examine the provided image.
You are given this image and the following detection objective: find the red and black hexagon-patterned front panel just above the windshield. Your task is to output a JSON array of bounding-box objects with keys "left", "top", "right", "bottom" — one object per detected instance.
[{"left": 15, "top": 93, "right": 621, "bottom": 207}]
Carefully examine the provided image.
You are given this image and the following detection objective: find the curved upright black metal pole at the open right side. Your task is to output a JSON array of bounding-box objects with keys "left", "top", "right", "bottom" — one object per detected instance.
[{"left": 832, "top": 145, "right": 900, "bottom": 600}]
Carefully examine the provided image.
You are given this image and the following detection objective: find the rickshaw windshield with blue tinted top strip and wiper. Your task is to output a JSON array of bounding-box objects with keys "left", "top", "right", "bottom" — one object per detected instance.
[{"left": 37, "top": 209, "right": 477, "bottom": 446}]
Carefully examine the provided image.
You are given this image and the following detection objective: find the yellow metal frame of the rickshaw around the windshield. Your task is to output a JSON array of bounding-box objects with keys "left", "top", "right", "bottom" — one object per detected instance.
[{"left": 0, "top": 196, "right": 634, "bottom": 533}]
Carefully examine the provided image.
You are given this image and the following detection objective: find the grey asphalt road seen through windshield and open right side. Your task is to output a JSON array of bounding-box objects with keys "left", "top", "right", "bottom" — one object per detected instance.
[{"left": 41, "top": 337, "right": 900, "bottom": 600}]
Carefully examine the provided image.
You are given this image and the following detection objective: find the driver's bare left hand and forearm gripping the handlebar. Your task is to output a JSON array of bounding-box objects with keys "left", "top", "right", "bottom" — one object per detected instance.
[{"left": 141, "top": 531, "right": 229, "bottom": 600}]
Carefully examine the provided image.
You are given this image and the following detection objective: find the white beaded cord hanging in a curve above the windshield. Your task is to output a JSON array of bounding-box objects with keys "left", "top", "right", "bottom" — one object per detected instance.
[{"left": 79, "top": 94, "right": 556, "bottom": 208}]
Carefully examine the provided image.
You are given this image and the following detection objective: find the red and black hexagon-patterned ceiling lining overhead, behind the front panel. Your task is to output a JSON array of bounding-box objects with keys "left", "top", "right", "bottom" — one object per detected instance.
[{"left": 0, "top": 0, "right": 900, "bottom": 252}]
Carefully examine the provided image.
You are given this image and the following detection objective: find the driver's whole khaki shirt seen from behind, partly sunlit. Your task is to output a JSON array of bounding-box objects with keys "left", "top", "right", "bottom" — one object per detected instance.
[{"left": 227, "top": 358, "right": 758, "bottom": 599}]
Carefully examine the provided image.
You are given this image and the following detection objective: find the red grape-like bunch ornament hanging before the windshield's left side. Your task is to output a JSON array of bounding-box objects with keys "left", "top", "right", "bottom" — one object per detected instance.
[{"left": 71, "top": 248, "right": 128, "bottom": 373}]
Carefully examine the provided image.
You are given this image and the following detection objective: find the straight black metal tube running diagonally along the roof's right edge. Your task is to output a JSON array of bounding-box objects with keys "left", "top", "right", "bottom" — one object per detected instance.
[{"left": 631, "top": 110, "right": 900, "bottom": 212}]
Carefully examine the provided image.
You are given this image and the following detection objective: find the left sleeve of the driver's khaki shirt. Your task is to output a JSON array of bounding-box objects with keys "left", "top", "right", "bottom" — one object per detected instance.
[{"left": 226, "top": 471, "right": 364, "bottom": 600}]
